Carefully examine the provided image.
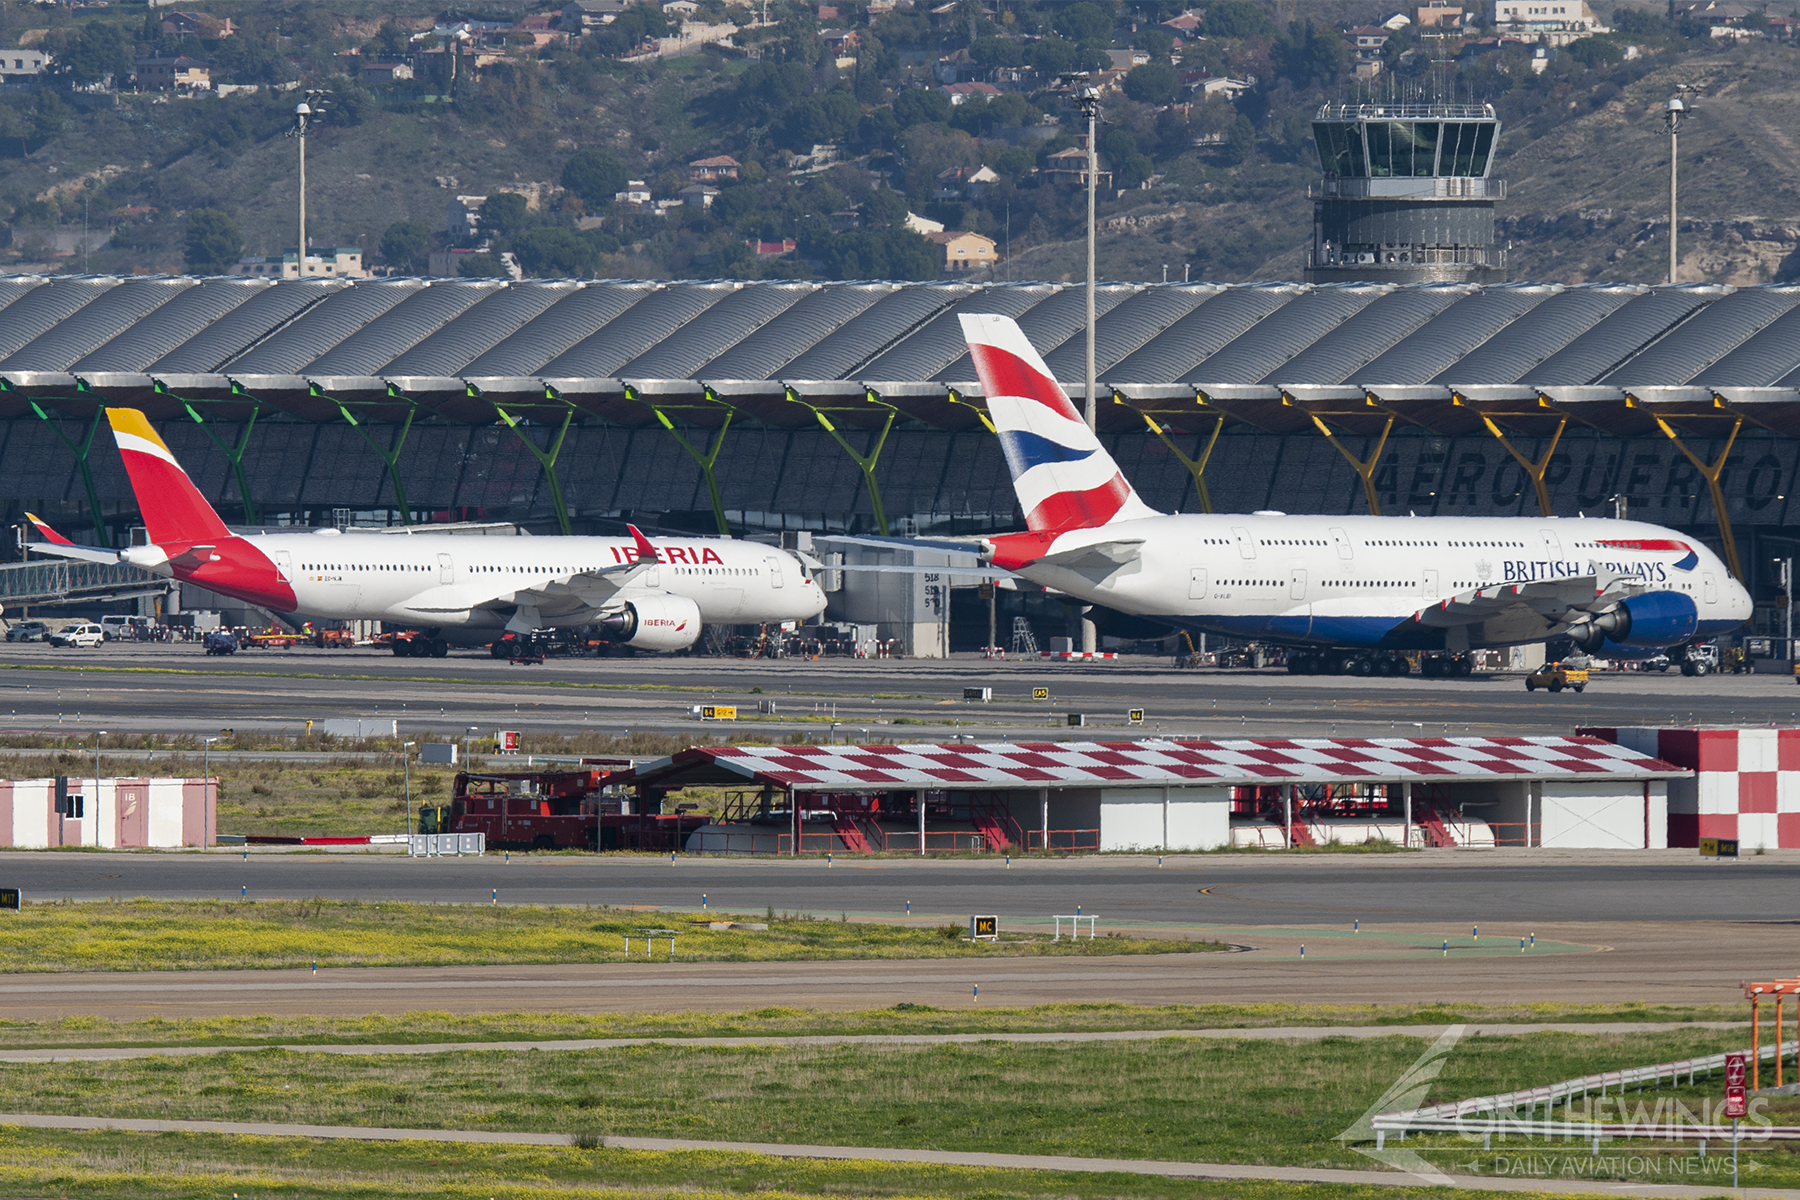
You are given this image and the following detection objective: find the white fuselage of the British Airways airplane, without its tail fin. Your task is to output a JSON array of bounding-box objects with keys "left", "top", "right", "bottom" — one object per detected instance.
[{"left": 1017, "top": 515, "right": 1751, "bottom": 646}]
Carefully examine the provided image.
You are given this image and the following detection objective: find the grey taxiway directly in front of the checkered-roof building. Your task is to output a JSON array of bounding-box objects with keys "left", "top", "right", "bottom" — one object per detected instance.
[{"left": 0, "top": 847, "right": 1800, "bottom": 934}]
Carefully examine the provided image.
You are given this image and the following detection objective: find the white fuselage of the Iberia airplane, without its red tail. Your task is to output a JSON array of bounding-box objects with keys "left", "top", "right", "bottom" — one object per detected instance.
[{"left": 165, "top": 529, "right": 824, "bottom": 630}]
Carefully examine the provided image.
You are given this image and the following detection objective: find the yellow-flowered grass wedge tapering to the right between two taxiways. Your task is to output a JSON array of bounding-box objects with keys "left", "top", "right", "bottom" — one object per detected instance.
[{"left": 0, "top": 900, "right": 1226, "bottom": 972}]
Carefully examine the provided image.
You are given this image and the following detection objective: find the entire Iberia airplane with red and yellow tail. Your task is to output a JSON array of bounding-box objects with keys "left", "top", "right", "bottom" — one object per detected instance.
[{"left": 32, "top": 408, "right": 824, "bottom": 655}]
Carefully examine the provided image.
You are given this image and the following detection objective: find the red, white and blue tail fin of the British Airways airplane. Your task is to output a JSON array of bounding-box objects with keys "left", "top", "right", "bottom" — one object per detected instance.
[{"left": 961, "top": 313, "right": 1156, "bottom": 533}]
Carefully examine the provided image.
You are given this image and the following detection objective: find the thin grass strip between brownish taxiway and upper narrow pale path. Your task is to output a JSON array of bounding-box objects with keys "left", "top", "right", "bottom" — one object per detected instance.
[{"left": 0, "top": 1004, "right": 1742, "bottom": 1049}]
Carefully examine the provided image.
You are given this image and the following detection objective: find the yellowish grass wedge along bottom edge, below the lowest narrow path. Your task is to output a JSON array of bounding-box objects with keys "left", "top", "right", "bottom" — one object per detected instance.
[{"left": 0, "top": 1128, "right": 1656, "bottom": 1200}]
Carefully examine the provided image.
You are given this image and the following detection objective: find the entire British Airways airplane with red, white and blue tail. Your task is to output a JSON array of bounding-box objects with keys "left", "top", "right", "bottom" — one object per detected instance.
[{"left": 961, "top": 315, "right": 1750, "bottom": 671}]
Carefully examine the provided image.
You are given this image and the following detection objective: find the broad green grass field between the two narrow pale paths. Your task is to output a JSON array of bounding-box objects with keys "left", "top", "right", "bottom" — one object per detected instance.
[{"left": 0, "top": 1029, "right": 1746, "bottom": 1168}]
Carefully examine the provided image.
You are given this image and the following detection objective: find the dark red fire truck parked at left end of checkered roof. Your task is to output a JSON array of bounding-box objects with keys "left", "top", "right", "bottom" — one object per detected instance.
[{"left": 443, "top": 761, "right": 706, "bottom": 853}]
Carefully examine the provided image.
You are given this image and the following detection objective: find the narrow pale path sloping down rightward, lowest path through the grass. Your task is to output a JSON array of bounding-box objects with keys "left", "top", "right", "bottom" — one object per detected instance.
[{"left": 0, "top": 1112, "right": 1771, "bottom": 1200}]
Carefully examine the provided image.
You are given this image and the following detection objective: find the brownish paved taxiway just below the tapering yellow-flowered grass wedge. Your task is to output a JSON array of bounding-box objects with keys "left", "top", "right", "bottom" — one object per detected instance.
[{"left": 0, "top": 921, "right": 1800, "bottom": 1020}]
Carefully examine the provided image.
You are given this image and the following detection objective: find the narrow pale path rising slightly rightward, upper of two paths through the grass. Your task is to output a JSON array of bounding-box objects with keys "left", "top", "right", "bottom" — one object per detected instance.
[{"left": 0, "top": 1020, "right": 1750, "bottom": 1063}]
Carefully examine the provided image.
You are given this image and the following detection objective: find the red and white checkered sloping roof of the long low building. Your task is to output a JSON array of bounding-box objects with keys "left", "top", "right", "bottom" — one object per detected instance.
[{"left": 610, "top": 738, "right": 1687, "bottom": 792}]
